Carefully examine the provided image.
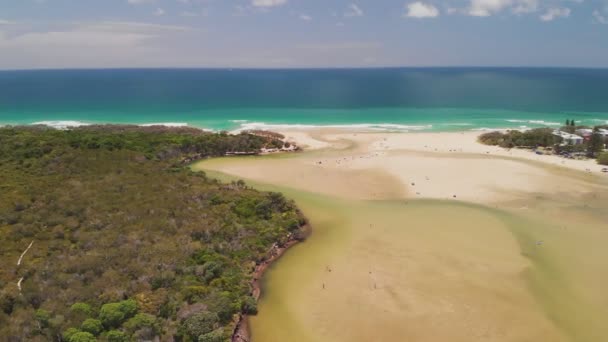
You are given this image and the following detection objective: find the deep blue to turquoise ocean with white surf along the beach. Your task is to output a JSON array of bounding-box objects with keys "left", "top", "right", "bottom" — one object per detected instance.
[{"left": 0, "top": 68, "right": 608, "bottom": 131}]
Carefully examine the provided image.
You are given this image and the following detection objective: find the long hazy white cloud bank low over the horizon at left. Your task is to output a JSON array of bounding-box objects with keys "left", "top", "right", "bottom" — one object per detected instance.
[{"left": 0, "top": 21, "right": 200, "bottom": 69}]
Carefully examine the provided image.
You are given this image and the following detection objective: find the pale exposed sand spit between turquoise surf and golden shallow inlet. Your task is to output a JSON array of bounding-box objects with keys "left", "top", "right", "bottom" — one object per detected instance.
[{"left": 216, "top": 129, "right": 608, "bottom": 204}]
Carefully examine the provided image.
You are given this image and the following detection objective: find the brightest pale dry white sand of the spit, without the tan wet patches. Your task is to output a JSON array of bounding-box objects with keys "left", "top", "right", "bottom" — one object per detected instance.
[{"left": 274, "top": 130, "right": 608, "bottom": 204}]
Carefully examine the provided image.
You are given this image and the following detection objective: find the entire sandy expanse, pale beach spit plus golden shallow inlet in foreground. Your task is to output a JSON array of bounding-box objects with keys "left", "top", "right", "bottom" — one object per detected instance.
[{"left": 194, "top": 130, "right": 608, "bottom": 342}]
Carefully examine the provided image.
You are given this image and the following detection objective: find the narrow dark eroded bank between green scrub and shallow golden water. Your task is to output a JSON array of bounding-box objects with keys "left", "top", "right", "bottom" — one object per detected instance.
[{"left": 231, "top": 223, "right": 311, "bottom": 342}]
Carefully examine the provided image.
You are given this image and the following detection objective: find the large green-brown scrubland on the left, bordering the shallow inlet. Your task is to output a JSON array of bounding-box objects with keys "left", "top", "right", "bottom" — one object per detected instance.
[{"left": 0, "top": 126, "right": 306, "bottom": 342}]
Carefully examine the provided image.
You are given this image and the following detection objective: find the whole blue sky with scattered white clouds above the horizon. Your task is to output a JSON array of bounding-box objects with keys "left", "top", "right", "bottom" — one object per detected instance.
[{"left": 0, "top": 0, "right": 608, "bottom": 69}]
